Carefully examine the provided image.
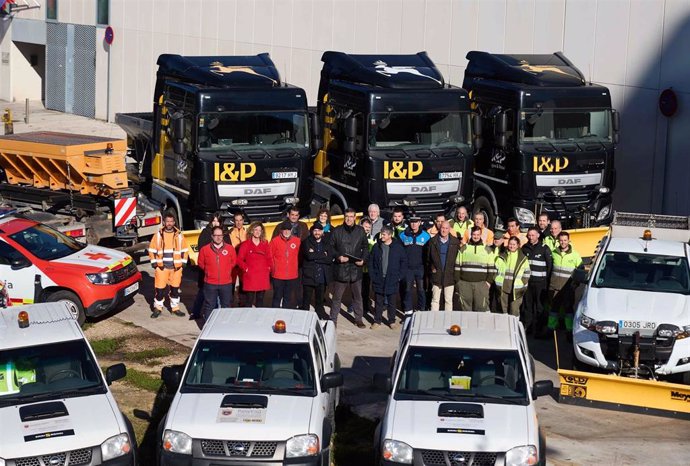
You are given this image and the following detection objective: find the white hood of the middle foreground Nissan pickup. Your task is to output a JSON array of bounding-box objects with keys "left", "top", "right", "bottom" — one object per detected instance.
[{"left": 165, "top": 393, "right": 314, "bottom": 441}]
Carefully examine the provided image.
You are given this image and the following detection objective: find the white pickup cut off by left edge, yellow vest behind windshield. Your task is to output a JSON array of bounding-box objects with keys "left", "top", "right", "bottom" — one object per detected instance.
[{"left": 0, "top": 303, "right": 136, "bottom": 466}]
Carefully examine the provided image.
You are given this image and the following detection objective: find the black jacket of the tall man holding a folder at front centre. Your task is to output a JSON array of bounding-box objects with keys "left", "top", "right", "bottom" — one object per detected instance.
[{"left": 331, "top": 224, "right": 369, "bottom": 283}]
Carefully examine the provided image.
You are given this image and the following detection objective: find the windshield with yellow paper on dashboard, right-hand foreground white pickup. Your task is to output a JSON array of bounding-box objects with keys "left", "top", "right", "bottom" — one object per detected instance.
[{"left": 395, "top": 346, "right": 529, "bottom": 404}]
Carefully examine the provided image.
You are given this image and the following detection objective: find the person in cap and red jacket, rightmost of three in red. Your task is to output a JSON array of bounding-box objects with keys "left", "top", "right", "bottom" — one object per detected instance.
[{"left": 269, "top": 221, "right": 301, "bottom": 309}]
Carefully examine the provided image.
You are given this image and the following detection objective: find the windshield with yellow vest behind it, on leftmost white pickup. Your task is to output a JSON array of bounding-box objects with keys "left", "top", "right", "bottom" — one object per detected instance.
[{"left": 0, "top": 340, "right": 106, "bottom": 406}]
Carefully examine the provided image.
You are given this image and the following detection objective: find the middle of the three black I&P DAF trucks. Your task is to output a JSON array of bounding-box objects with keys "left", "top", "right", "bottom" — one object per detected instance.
[{"left": 314, "top": 52, "right": 474, "bottom": 215}]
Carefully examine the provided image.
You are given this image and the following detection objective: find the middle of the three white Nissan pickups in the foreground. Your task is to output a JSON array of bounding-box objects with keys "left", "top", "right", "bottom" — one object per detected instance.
[{"left": 158, "top": 308, "right": 343, "bottom": 466}]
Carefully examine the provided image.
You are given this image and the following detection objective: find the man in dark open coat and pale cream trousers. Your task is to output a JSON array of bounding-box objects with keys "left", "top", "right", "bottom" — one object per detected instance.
[{"left": 426, "top": 221, "right": 460, "bottom": 311}]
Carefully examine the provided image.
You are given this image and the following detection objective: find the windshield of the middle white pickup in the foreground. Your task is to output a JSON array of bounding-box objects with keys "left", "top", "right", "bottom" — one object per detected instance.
[{"left": 180, "top": 340, "right": 316, "bottom": 396}]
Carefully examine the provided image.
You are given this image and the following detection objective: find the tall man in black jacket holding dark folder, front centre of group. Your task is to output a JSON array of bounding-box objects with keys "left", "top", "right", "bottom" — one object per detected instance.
[{"left": 331, "top": 209, "right": 369, "bottom": 328}]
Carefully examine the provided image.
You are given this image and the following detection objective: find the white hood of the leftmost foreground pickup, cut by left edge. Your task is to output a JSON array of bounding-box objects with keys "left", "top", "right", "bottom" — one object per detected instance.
[{"left": 0, "top": 394, "right": 122, "bottom": 459}]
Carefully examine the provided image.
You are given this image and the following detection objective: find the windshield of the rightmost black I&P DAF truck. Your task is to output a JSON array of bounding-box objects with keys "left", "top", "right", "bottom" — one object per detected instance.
[{"left": 520, "top": 109, "right": 612, "bottom": 143}]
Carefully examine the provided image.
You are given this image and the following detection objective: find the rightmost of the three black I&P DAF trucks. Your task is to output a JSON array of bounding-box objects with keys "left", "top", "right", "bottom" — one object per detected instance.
[{"left": 463, "top": 52, "right": 619, "bottom": 228}]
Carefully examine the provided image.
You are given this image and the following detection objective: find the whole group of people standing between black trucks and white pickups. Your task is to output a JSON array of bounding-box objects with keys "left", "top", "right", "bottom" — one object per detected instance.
[{"left": 149, "top": 204, "right": 582, "bottom": 336}]
